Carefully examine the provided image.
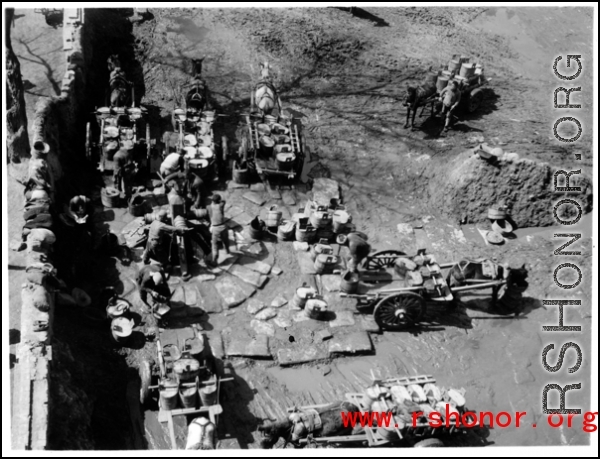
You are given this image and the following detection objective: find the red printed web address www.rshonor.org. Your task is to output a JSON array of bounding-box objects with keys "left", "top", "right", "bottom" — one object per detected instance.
[{"left": 340, "top": 409, "right": 598, "bottom": 433}]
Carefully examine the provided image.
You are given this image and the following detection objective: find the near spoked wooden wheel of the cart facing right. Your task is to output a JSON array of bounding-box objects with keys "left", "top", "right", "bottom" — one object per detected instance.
[{"left": 373, "top": 292, "right": 425, "bottom": 330}]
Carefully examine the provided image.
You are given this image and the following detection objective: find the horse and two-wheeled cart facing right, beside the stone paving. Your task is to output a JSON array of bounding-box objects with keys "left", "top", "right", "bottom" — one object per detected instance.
[{"left": 340, "top": 250, "right": 514, "bottom": 330}]
